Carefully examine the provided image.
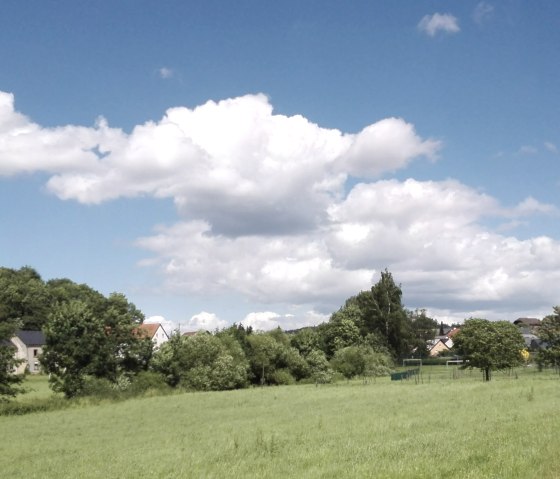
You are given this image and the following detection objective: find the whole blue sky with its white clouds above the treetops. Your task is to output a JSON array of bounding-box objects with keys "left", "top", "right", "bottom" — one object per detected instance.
[{"left": 0, "top": 0, "right": 560, "bottom": 331}]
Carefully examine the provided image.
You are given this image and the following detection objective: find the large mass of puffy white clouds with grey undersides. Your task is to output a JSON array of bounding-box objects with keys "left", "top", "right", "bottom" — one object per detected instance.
[{"left": 0, "top": 92, "right": 560, "bottom": 322}]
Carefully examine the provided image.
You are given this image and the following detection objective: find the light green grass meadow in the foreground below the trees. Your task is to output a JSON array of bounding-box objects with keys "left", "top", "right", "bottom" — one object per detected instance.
[{"left": 0, "top": 367, "right": 560, "bottom": 479}]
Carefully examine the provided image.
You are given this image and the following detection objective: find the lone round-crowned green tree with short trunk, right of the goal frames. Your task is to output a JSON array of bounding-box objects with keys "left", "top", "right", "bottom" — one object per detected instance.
[{"left": 453, "top": 319, "right": 525, "bottom": 381}]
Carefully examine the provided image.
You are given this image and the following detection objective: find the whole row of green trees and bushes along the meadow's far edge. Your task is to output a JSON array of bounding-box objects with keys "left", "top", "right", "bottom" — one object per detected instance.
[{"left": 0, "top": 267, "right": 560, "bottom": 397}]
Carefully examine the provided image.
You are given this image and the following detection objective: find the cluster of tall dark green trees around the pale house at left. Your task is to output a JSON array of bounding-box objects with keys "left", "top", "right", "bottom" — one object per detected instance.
[{"left": 0, "top": 267, "right": 152, "bottom": 397}]
